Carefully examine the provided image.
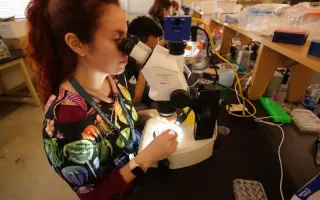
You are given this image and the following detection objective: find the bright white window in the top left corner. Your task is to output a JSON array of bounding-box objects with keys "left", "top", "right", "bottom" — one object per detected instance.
[{"left": 0, "top": 0, "right": 30, "bottom": 18}]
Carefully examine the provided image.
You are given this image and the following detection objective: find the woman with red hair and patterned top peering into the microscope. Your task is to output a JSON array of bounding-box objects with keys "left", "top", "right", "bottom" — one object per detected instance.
[{"left": 26, "top": 0, "right": 178, "bottom": 200}]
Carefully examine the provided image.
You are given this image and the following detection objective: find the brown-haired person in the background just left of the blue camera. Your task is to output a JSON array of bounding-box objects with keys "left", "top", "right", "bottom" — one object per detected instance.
[{"left": 149, "top": 0, "right": 171, "bottom": 46}]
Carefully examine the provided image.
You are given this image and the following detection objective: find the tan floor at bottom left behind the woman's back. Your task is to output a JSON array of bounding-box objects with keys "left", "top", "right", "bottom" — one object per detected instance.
[{"left": 0, "top": 103, "right": 78, "bottom": 200}]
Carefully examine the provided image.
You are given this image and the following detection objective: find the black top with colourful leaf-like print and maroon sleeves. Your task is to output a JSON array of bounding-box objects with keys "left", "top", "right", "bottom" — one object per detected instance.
[{"left": 43, "top": 77, "right": 141, "bottom": 200}]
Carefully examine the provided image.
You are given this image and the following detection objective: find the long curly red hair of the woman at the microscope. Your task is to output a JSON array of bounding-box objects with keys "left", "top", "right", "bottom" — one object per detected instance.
[{"left": 26, "top": 0, "right": 119, "bottom": 104}]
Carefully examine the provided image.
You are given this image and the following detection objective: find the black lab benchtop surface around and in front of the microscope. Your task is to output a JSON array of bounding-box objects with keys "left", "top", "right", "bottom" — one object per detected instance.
[{"left": 123, "top": 99, "right": 320, "bottom": 200}]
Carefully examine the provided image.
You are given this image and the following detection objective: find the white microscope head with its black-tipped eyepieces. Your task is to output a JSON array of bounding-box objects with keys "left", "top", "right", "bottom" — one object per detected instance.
[{"left": 119, "top": 36, "right": 188, "bottom": 102}]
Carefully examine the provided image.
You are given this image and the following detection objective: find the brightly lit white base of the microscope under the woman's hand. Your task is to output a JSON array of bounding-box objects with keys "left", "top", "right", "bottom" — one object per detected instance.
[{"left": 139, "top": 118, "right": 217, "bottom": 169}]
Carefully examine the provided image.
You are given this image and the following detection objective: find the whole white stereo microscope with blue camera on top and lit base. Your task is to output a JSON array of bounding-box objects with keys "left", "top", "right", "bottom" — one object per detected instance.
[{"left": 119, "top": 16, "right": 221, "bottom": 169}]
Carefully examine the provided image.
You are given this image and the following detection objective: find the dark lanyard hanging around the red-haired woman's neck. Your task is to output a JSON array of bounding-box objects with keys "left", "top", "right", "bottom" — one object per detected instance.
[{"left": 69, "top": 77, "right": 139, "bottom": 153}]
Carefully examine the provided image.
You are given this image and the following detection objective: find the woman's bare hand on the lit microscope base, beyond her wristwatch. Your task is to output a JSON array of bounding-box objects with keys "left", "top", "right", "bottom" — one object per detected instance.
[{"left": 135, "top": 130, "right": 178, "bottom": 169}]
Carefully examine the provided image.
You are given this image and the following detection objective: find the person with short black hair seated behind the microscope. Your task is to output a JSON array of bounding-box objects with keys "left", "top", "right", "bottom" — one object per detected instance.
[{"left": 125, "top": 16, "right": 163, "bottom": 110}]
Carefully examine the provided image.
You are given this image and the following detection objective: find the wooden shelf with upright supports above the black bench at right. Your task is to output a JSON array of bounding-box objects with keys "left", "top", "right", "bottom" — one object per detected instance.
[{"left": 210, "top": 19, "right": 320, "bottom": 102}]
